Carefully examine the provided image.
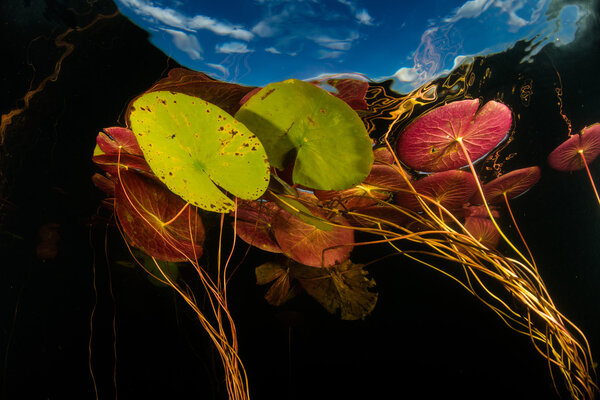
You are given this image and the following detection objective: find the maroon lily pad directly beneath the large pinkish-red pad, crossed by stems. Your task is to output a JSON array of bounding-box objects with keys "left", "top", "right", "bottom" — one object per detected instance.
[{"left": 396, "top": 170, "right": 477, "bottom": 211}]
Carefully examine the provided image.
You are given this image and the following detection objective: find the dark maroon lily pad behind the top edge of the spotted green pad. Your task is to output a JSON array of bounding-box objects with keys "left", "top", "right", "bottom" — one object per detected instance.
[{"left": 137, "top": 68, "right": 254, "bottom": 115}]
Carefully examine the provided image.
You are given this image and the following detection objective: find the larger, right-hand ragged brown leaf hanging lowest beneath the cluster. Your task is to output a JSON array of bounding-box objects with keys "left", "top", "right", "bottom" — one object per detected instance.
[{"left": 292, "top": 260, "right": 377, "bottom": 320}]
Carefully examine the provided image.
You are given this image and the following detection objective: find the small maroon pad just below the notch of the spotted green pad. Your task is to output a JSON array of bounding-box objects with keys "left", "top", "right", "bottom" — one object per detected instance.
[{"left": 236, "top": 201, "right": 281, "bottom": 253}]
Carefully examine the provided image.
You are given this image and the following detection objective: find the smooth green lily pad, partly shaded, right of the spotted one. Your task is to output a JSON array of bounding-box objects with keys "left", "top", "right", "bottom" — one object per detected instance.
[{"left": 235, "top": 79, "right": 373, "bottom": 190}]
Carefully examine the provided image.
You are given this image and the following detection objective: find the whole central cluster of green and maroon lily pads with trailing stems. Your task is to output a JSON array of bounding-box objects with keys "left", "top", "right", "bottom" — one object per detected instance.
[{"left": 93, "top": 70, "right": 598, "bottom": 399}]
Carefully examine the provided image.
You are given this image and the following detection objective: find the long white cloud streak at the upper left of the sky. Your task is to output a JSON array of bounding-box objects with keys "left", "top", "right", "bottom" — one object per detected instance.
[{"left": 121, "top": 0, "right": 254, "bottom": 41}]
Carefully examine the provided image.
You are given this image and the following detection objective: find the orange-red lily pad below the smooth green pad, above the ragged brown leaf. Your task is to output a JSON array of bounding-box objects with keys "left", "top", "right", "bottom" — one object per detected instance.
[{"left": 273, "top": 209, "right": 354, "bottom": 267}]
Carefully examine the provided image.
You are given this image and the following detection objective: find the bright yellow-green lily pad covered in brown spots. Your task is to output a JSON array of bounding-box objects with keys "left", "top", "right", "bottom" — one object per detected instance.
[{"left": 128, "top": 91, "right": 269, "bottom": 212}]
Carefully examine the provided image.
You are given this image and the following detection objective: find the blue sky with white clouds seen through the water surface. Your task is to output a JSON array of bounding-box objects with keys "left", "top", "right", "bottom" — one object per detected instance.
[{"left": 116, "top": 0, "right": 591, "bottom": 92}]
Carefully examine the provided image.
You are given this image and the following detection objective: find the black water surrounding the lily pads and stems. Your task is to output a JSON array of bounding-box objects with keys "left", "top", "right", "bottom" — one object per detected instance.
[{"left": 0, "top": 1, "right": 600, "bottom": 399}]
